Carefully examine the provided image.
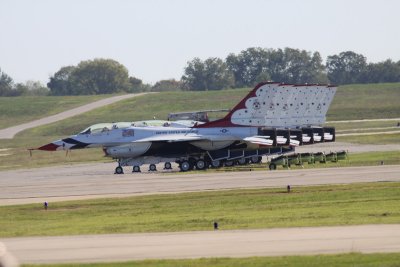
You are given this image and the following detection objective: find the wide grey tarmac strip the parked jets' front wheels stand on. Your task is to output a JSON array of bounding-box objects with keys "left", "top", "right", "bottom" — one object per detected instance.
[{"left": 0, "top": 163, "right": 400, "bottom": 205}]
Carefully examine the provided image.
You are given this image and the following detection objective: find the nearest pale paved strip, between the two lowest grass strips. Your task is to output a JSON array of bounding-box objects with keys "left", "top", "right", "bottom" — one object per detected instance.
[{"left": 2, "top": 224, "right": 400, "bottom": 263}]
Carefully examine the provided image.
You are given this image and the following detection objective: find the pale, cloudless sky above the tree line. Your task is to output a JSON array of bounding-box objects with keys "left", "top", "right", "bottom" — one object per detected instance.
[{"left": 0, "top": 0, "right": 400, "bottom": 84}]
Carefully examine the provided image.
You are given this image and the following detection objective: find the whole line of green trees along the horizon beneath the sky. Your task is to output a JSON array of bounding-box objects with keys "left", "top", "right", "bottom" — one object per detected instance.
[{"left": 0, "top": 47, "right": 400, "bottom": 96}]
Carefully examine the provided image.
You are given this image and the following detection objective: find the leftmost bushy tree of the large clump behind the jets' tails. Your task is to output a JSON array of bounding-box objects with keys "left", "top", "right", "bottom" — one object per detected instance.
[{"left": 181, "top": 58, "right": 234, "bottom": 91}]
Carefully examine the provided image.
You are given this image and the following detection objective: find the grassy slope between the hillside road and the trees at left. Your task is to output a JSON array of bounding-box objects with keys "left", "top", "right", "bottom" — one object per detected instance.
[{"left": 0, "top": 95, "right": 111, "bottom": 129}]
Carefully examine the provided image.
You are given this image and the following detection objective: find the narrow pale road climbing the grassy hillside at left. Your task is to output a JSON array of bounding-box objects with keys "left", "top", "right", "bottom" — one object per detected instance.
[{"left": 0, "top": 93, "right": 144, "bottom": 139}]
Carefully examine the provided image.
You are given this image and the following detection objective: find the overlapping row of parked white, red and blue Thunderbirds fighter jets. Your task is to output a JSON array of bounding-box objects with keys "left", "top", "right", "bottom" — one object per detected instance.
[{"left": 37, "top": 82, "right": 336, "bottom": 174}]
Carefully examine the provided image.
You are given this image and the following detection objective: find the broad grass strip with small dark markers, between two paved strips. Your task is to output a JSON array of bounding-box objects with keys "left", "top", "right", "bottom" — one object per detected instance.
[{"left": 0, "top": 182, "right": 400, "bottom": 237}]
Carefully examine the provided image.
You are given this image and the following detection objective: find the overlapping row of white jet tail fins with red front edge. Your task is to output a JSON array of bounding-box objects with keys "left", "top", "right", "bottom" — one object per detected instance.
[{"left": 198, "top": 82, "right": 336, "bottom": 128}]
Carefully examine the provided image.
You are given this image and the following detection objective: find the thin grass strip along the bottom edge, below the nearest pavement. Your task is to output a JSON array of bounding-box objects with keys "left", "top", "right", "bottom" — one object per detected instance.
[{"left": 23, "top": 253, "right": 400, "bottom": 267}]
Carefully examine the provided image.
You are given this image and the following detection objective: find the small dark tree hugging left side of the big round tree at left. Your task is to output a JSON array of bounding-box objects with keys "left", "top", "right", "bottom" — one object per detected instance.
[{"left": 47, "top": 66, "right": 76, "bottom": 95}]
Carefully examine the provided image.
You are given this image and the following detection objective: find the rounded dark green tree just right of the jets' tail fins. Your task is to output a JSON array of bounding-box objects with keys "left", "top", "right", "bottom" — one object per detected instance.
[{"left": 326, "top": 51, "right": 367, "bottom": 84}]
